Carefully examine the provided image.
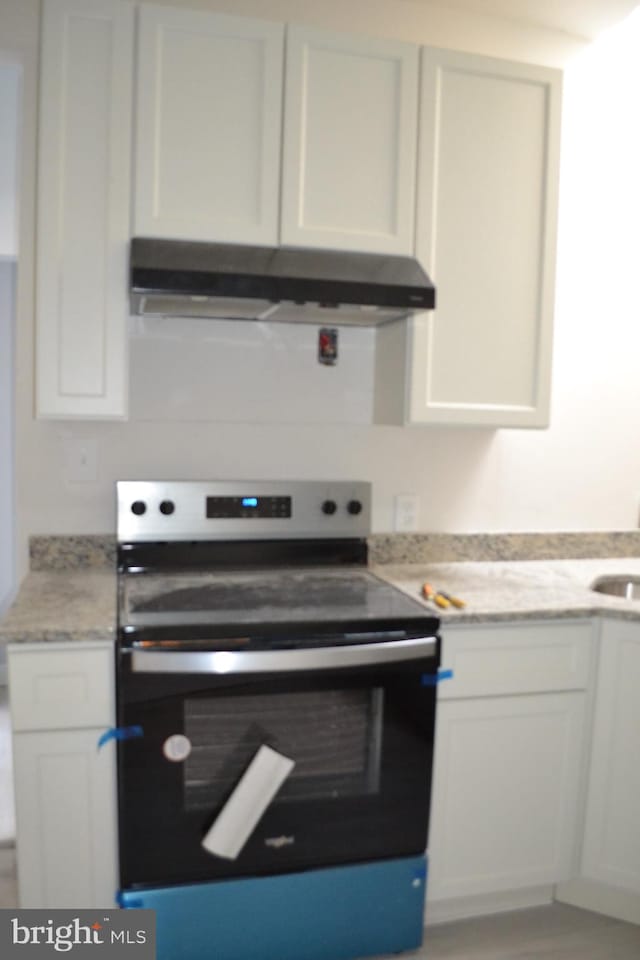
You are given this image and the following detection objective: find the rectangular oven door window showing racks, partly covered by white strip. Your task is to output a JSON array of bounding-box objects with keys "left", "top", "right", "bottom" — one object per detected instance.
[{"left": 183, "top": 687, "right": 384, "bottom": 810}]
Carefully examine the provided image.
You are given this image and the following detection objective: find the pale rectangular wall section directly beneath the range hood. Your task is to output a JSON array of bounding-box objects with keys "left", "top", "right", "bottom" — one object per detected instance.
[{"left": 129, "top": 315, "right": 375, "bottom": 424}]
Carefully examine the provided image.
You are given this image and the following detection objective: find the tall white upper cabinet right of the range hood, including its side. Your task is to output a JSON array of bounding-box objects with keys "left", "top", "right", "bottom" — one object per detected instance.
[{"left": 376, "top": 48, "right": 561, "bottom": 427}]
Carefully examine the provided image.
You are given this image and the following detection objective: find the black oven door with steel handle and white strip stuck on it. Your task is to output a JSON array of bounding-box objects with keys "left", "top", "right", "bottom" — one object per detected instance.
[{"left": 118, "top": 637, "right": 439, "bottom": 889}]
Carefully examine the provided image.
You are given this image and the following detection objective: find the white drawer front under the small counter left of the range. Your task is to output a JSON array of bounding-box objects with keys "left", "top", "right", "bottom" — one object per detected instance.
[{"left": 9, "top": 647, "right": 114, "bottom": 731}]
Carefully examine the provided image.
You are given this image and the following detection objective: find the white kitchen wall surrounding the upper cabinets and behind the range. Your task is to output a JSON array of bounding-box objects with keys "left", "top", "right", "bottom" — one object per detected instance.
[{"left": 5, "top": 0, "right": 640, "bottom": 584}]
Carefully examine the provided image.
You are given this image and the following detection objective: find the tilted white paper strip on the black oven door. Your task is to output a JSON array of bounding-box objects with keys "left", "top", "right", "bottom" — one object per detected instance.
[{"left": 202, "top": 744, "right": 295, "bottom": 860}]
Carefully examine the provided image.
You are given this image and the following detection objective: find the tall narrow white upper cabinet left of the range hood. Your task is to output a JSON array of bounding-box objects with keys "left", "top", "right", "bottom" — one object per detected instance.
[{"left": 36, "top": 0, "right": 134, "bottom": 418}]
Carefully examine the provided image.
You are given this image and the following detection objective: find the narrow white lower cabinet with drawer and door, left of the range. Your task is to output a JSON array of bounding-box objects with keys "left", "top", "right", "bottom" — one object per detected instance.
[{"left": 8, "top": 643, "right": 117, "bottom": 908}]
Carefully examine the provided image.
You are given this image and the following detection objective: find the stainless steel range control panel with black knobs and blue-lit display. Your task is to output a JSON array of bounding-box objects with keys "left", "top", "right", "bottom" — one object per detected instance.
[{"left": 116, "top": 480, "right": 371, "bottom": 543}]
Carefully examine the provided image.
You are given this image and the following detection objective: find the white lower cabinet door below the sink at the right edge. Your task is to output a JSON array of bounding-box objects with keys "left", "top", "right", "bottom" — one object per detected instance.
[{"left": 582, "top": 621, "right": 640, "bottom": 892}]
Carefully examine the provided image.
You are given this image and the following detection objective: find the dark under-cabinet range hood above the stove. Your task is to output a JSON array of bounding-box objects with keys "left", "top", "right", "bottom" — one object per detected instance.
[{"left": 131, "top": 237, "right": 435, "bottom": 327}]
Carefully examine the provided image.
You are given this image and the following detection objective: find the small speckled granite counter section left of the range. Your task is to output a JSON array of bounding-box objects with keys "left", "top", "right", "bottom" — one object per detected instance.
[{"left": 0, "top": 567, "right": 116, "bottom": 643}]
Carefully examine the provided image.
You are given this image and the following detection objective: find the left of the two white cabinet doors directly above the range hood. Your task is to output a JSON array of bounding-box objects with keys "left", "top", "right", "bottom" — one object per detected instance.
[{"left": 134, "top": 5, "right": 284, "bottom": 244}]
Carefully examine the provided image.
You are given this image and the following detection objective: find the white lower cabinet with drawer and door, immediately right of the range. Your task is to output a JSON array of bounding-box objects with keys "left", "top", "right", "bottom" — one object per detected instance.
[{"left": 427, "top": 621, "right": 593, "bottom": 919}]
